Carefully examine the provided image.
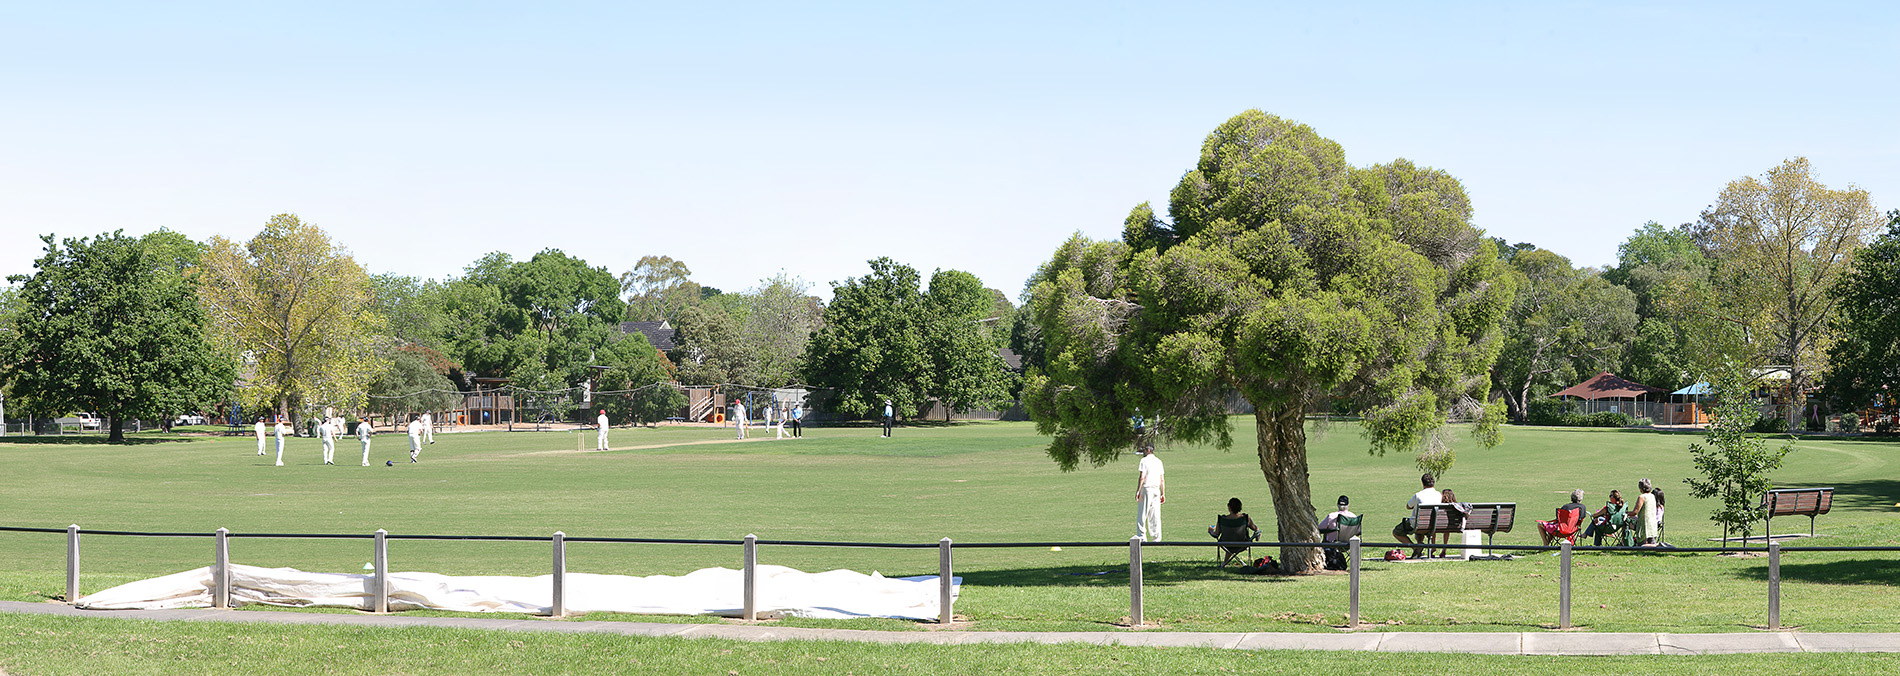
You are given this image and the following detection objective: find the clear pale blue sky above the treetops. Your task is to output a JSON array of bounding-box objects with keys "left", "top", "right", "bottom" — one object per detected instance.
[{"left": 0, "top": 2, "right": 1900, "bottom": 296}]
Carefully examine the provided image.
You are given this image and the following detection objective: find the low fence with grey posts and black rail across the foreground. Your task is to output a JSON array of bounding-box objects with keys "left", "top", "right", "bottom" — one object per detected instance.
[{"left": 0, "top": 524, "right": 1900, "bottom": 630}]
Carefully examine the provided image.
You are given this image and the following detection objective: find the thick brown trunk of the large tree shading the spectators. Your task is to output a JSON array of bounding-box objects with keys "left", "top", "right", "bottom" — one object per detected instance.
[{"left": 1254, "top": 403, "right": 1326, "bottom": 575}]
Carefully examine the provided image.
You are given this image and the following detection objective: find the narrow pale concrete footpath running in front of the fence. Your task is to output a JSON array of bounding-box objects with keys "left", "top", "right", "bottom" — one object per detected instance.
[{"left": 0, "top": 602, "right": 1900, "bottom": 655}]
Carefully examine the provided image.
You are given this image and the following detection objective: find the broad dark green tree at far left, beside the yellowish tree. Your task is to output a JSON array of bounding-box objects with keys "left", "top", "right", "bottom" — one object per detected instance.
[{"left": 0, "top": 230, "right": 236, "bottom": 442}]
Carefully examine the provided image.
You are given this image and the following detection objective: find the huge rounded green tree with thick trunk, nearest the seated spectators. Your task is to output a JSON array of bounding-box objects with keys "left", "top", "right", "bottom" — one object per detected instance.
[{"left": 1024, "top": 110, "right": 1514, "bottom": 572}]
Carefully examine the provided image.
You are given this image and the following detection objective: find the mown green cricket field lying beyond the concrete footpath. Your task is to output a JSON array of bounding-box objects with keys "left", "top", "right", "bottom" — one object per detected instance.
[{"left": 0, "top": 418, "right": 1900, "bottom": 672}]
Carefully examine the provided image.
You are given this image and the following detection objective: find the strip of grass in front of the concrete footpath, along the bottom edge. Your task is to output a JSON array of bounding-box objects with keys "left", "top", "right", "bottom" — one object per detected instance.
[{"left": 0, "top": 613, "right": 1900, "bottom": 676}]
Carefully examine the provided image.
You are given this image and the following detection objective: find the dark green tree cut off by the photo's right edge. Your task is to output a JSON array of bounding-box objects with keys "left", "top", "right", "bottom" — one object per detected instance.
[{"left": 1826, "top": 209, "right": 1900, "bottom": 410}]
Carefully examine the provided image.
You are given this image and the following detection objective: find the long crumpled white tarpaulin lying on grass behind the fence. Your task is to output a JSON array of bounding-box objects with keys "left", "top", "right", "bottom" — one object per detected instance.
[{"left": 80, "top": 564, "right": 963, "bottom": 619}]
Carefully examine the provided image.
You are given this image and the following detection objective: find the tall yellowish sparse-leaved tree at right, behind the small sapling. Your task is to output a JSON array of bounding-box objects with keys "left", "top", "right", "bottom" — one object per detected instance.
[{"left": 1702, "top": 158, "right": 1881, "bottom": 429}]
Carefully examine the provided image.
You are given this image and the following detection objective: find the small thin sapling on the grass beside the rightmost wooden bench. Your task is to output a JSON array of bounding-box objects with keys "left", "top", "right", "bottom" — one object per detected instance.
[{"left": 1683, "top": 361, "right": 1794, "bottom": 547}]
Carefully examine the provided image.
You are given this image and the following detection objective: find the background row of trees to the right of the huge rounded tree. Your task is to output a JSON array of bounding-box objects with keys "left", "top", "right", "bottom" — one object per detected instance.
[{"left": 1492, "top": 158, "right": 1900, "bottom": 425}]
